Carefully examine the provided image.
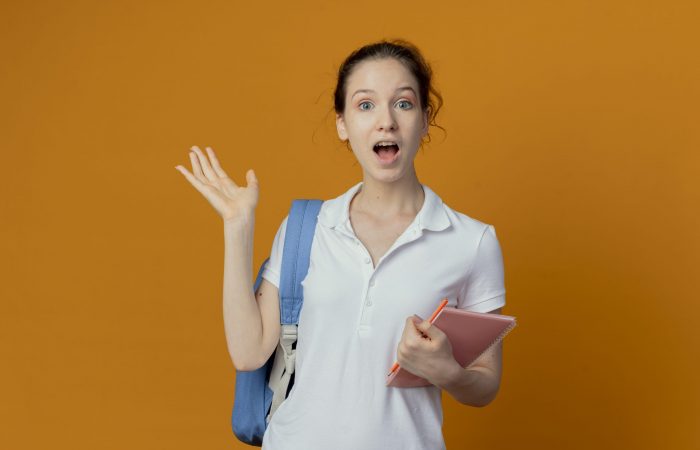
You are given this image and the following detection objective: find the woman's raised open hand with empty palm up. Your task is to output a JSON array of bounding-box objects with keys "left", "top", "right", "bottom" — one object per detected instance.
[{"left": 175, "top": 146, "right": 259, "bottom": 222}]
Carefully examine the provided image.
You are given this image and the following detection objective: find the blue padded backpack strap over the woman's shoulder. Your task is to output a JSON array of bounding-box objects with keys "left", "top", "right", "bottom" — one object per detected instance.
[{"left": 279, "top": 199, "right": 323, "bottom": 325}]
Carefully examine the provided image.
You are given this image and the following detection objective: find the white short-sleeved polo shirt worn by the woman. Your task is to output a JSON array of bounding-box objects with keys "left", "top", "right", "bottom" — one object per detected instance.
[{"left": 262, "top": 182, "right": 505, "bottom": 450}]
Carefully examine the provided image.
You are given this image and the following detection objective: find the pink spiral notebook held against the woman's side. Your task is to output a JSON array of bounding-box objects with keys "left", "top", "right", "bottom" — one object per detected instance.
[{"left": 386, "top": 307, "right": 515, "bottom": 387}]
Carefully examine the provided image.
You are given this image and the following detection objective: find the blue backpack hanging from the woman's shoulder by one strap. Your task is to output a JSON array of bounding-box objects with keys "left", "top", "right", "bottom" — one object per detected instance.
[{"left": 231, "top": 199, "right": 323, "bottom": 447}]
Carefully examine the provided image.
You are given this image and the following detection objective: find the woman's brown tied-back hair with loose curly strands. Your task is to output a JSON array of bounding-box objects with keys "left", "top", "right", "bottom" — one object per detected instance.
[{"left": 333, "top": 39, "right": 445, "bottom": 149}]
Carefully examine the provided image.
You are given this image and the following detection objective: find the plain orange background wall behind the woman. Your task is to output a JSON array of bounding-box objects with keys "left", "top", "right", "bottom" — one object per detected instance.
[{"left": 0, "top": 0, "right": 700, "bottom": 449}]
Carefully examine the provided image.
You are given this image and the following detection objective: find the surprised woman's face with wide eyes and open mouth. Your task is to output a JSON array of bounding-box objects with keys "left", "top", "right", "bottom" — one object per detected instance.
[{"left": 336, "top": 58, "right": 428, "bottom": 182}]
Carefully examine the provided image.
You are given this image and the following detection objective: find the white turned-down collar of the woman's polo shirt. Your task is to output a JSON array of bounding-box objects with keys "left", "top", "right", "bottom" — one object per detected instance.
[{"left": 318, "top": 181, "right": 451, "bottom": 231}]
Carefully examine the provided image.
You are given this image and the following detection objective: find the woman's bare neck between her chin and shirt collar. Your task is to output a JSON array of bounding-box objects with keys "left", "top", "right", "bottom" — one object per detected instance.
[{"left": 353, "top": 172, "right": 425, "bottom": 219}]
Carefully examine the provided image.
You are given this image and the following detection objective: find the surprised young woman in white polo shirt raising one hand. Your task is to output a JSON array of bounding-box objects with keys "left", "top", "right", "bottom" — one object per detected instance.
[{"left": 178, "top": 41, "right": 505, "bottom": 450}]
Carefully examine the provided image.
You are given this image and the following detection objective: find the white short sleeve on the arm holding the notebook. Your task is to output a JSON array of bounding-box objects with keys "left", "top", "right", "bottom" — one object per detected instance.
[{"left": 458, "top": 225, "right": 506, "bottom": 313}]
